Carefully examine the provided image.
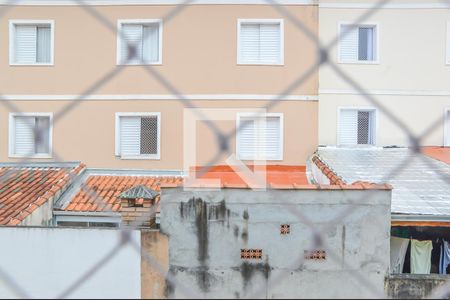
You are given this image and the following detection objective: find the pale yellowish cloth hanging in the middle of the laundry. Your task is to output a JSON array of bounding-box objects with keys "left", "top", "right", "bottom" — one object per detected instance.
[{"left": 411, "top": 240, "right": 433, "bottom": 274}]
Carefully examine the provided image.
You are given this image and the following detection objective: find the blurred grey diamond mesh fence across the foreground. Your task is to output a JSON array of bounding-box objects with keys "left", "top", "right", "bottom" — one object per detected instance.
[{"left": 0, "top": 0, "right": 450, "bottom": 299}]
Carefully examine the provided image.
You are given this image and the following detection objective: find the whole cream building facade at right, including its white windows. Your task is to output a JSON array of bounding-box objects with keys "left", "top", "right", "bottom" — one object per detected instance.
[{"left": 319, "top": 0, "right": 450, "bottom": 146}]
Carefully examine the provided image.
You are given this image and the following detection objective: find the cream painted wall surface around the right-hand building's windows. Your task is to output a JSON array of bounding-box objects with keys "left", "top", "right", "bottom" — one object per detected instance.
[{"left": 319, "top": 0, "right": 450, "bottom": 145}]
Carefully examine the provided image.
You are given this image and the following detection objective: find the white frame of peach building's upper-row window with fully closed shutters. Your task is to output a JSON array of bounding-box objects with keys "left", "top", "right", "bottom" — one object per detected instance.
[{"left": 236, "top": 19, "right": 284, "bottom": 66}]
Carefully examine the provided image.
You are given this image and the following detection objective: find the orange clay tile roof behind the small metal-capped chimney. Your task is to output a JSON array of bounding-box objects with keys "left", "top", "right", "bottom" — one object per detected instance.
[{"left": 62, "top": 175, "right": 183, "bottom": 212}]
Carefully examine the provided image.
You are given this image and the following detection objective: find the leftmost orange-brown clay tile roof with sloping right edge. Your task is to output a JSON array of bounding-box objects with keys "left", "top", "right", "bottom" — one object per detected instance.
[{"left": 0, "top": 164, "right": 85, "bottom": 226}]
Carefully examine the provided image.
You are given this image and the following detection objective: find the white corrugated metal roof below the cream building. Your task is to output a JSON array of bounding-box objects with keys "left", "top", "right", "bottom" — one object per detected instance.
[{"left": 317, "top": 147, "right": 450, "bottom": 216}]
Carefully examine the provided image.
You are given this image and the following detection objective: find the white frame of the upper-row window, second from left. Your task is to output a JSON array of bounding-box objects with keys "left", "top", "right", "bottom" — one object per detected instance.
[{"left": 116, "top": 19, "right": 163, "bottom": 66}]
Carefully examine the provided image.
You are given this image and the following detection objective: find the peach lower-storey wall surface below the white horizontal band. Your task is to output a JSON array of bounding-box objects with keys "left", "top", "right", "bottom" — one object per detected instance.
[{"left": 0, "top": 100, "right": 318, "bottom": 170}]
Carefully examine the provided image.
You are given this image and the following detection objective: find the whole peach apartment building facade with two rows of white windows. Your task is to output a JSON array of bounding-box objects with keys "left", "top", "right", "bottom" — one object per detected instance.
[{"left": 0, "top": 0, "right": 318, "bottom": 170}]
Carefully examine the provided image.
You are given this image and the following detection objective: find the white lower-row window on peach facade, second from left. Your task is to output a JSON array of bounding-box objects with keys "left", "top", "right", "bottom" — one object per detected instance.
[{"left": 116, "top": 113, "right": 161, "bottom": 159}]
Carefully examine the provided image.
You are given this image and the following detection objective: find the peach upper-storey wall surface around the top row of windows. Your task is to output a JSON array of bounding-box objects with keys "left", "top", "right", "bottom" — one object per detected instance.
[{"left": 0, "top": 5, "right": 318, "bottom": 95}]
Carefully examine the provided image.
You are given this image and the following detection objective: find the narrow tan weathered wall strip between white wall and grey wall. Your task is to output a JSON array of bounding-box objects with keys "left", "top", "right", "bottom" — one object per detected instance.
[{"left": 141, "top": 230, "right": 169, "bottom": 299}]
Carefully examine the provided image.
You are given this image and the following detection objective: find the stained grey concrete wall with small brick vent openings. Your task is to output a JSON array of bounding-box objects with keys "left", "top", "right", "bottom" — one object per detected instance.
[{"left": 161, "top": 188, "right": 391, "bottom": 298}]
